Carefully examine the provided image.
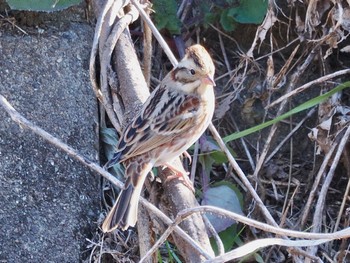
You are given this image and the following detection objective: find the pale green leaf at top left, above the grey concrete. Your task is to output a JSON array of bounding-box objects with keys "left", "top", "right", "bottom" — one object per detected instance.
[{"left": 6, "top": 0, "right": 81, "bottom": 12}]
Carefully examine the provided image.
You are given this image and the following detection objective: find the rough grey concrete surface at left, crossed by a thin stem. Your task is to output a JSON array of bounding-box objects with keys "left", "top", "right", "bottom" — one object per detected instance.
[{"left": 0, "top": 13, "right": 100, "bottom": 263}]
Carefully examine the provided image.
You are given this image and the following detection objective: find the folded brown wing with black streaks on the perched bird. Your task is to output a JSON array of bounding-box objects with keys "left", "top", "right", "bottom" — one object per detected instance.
[{"left": 117, "top": 87, "right": 202, "bottom": 161}]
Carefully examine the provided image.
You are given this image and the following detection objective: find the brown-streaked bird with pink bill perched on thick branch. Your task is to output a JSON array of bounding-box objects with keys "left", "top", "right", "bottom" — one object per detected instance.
[{"left": 102, "top": 45, "right": 215, "bottom": 232}]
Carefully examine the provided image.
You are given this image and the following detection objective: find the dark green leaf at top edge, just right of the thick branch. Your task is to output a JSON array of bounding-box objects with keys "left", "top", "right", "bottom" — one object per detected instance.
[{"left": 153, "top": 0, "right": 181, "bottom": 35}]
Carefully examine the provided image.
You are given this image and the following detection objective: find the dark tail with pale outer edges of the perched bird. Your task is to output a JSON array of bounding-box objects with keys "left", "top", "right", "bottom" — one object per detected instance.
[{"left": 102, "top": 164, "right": 152, "bottom": 233}]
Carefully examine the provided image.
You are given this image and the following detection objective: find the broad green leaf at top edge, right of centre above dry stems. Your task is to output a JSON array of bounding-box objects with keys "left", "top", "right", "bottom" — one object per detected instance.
[{"left": 227, "top": 0, "right": 268, "bottom": 24}]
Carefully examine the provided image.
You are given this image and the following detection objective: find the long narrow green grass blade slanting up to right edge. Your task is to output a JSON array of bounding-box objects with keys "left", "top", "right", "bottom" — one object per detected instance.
[{"left": 223, "top": 81, "right": 350, "bottom": 143}]
